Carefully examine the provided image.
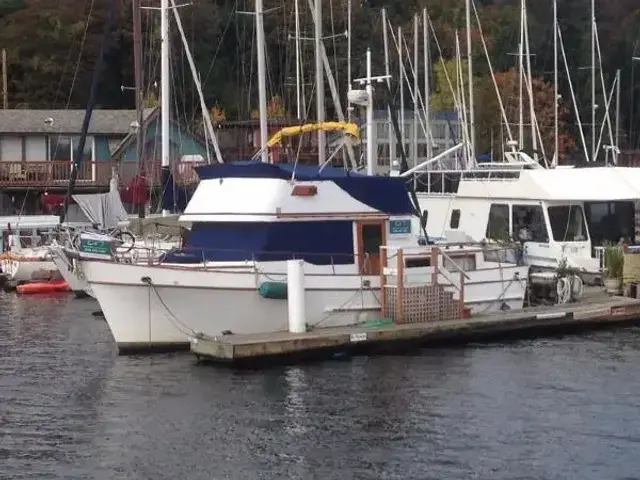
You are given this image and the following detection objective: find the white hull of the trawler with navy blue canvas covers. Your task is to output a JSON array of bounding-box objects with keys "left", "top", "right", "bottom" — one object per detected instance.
[{"left": 80, "top": 260, "right": 528, "bottom": 353}]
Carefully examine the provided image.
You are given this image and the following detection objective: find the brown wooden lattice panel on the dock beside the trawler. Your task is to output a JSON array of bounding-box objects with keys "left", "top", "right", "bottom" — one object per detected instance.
[{"left": 385, "top": 284, "right": 461, "bottom": 324}]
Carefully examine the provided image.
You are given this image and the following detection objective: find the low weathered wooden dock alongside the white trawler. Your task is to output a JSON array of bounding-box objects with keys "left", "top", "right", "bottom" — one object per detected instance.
[{"left": 191, "top": 290, "right": 640, "bottom": 366}]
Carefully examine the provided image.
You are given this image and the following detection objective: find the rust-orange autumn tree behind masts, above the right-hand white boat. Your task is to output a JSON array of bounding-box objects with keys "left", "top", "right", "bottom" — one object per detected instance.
[{"left": 474, "top": 68, "right": 575, "bottom": 163}]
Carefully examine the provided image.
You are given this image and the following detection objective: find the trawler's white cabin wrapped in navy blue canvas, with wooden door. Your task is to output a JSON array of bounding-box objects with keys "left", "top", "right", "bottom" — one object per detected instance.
[{"left": 164, "top": 162, "right": 417, "bottom": 275}]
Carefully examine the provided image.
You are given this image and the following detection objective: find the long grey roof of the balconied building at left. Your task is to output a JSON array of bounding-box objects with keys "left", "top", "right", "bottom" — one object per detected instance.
[{"left": 0, "top": 108, "right": 154, "bottom": 135}]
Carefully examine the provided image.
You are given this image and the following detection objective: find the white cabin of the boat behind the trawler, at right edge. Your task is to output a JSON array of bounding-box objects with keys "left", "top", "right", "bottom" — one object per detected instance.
[{"left": 416, "top": 166, "right": 640, "bottom": 273}]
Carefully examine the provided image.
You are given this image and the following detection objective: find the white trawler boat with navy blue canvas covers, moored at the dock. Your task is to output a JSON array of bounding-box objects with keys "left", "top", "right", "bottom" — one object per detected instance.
[{"left": 74, "top": 163, "right": 528, "bottom": 352}]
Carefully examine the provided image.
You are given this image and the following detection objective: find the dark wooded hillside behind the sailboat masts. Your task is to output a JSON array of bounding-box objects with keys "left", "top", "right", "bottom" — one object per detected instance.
[{"left": 0, "top": 0, "right": 640, "bottom": 159}]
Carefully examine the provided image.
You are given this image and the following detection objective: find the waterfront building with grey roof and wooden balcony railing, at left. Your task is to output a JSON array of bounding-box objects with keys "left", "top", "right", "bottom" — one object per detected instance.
[{"left": 0, "top": 108, "right": 207, "bottom": 215}]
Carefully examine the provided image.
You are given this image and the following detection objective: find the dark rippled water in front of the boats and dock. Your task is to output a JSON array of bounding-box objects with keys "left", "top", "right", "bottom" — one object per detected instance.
[{"left": 0, "top": 295, "right": 640, "bottom": 480}]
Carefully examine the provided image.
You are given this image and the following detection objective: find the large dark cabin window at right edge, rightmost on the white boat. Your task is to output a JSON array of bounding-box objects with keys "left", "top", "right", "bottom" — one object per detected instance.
[{"left": 584, "top": 202, "right": 636, "bottom": 246}]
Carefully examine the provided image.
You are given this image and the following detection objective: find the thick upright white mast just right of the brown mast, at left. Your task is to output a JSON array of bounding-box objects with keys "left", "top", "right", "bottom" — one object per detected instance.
[{"left": 160, "top": 0, "right": 171, "bottom": 216}]
